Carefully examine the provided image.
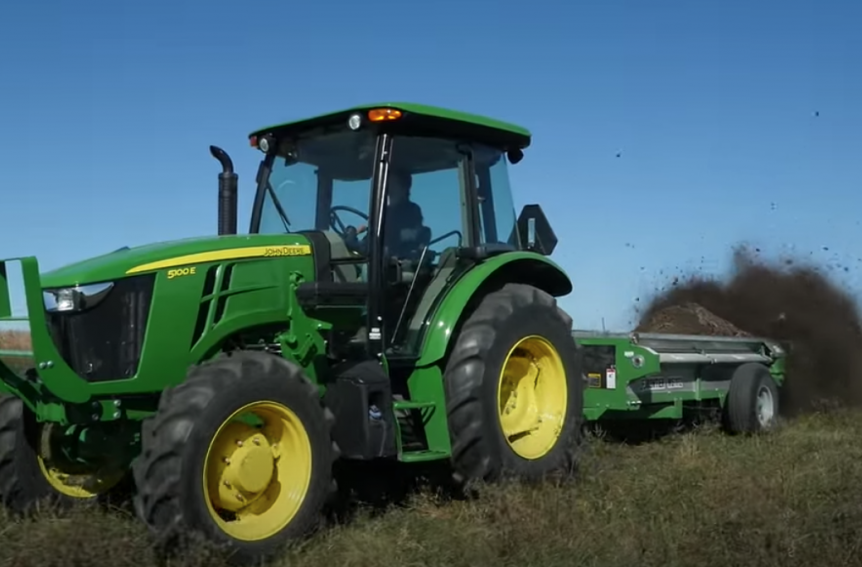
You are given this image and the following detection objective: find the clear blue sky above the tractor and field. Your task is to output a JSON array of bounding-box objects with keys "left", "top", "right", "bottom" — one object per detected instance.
[{"left": 0, "top": 0, "right": 862, "bottom": 330}]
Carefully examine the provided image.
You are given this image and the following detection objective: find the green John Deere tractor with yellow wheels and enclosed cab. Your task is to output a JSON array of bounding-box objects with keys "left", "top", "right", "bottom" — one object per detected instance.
[{"left": 0, "top": 103, "right": 585, "bottom": 561}]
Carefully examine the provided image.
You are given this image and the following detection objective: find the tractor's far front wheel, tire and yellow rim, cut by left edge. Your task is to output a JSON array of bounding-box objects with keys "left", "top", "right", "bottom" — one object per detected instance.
[{"left": 0, "top": 395, "right": 125, "bottom": 513}]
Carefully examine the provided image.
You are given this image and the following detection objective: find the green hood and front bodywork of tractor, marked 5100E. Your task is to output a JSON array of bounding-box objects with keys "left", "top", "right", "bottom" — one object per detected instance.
[{"left": 0, "top": 234, "right": 330, "bottom": 421}]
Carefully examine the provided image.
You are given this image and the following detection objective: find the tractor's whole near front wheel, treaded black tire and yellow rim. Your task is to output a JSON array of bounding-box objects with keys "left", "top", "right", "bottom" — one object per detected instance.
[{"left": 133, "top": 352, "right": 338, "bottom": 564}]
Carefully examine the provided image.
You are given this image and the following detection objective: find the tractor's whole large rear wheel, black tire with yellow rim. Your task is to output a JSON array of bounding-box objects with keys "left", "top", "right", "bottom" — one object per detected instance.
[{"left": 444, "top": 284, "right": 585, "bottom": 482}]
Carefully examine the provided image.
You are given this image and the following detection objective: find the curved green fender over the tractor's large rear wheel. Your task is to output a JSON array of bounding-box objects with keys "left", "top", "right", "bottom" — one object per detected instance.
[{"left": 416, "top": 252, "right": 572, "bottom": 367}]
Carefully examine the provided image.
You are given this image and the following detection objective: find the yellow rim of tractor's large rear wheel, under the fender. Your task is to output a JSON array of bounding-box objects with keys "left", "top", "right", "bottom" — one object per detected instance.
[{"left": 497, "top": 336, "right": 568, "bottom": 460}]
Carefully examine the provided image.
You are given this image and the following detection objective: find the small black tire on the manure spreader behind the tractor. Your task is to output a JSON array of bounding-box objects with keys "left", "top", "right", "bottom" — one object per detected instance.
[{"left": 724, "top": 362, "right": 780, "bottom": 434}]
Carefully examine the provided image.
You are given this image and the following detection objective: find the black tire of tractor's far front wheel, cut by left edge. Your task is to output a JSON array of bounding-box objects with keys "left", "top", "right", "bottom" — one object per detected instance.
[{"left": 0, "top": 395, "right": 126, "bottom": 514}]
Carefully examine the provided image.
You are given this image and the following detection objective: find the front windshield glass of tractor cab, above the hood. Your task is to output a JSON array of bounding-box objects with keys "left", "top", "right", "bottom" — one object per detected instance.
[{"left": 259, "top": 130, "right": 376, "bottom": 234}]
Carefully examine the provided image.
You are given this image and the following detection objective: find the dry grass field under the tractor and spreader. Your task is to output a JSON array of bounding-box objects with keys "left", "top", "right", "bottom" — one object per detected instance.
[{"left": 0, "top": 412, "right": 862, "bottom": 567}]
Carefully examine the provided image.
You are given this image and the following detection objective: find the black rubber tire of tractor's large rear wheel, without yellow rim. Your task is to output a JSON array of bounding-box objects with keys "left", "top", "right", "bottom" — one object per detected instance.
[{"left": 444, "top": 284, "right": 585, "bottom": 483}]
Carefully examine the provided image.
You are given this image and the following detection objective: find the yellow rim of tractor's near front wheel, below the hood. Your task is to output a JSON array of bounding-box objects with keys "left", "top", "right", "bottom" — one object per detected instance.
[{"left": 203, "top": 402, "right": 312, "bottom": 541}]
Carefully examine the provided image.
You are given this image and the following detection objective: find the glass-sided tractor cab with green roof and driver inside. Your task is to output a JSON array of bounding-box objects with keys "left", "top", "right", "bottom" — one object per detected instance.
[{"left": 243, "top": 105, "right": 552, "bottom": 359}]
